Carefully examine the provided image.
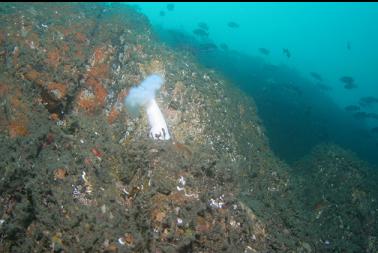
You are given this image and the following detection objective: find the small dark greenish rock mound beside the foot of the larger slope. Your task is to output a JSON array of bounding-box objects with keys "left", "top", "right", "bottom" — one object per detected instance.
[{"left": 293, "top": 144, "right": 378, "bottom": 252}]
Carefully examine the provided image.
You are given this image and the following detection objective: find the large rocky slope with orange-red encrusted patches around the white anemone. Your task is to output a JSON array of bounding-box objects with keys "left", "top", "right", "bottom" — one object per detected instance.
[{"left": 0, "top": 3, "right": 376, "bottom": 252}]
